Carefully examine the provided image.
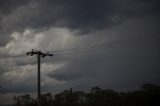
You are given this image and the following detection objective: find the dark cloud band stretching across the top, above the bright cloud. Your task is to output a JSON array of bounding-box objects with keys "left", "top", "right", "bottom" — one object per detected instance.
[{"left": 0, "top": 0, "right": 160, "bottom": 39}]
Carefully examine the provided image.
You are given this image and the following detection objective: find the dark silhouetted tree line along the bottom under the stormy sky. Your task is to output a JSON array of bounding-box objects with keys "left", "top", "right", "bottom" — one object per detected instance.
[{"left": 13, "top": 84, "right": 160, "bottom": 106}]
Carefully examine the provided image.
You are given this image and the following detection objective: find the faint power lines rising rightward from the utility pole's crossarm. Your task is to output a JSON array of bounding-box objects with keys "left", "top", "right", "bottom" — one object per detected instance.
[{"left": 52, "top": 35, "right": 159, "bottom": 55}]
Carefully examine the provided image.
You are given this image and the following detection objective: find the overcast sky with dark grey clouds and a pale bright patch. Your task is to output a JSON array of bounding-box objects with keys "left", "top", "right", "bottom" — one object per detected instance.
[{"left": 0, "top": 0, "right": 160, "bottom": 103}]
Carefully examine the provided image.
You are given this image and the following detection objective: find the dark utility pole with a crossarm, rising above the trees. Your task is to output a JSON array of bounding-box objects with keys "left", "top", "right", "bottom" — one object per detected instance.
[{"left": 26, "top": 49, "right": 53, "bottom": 106}]
